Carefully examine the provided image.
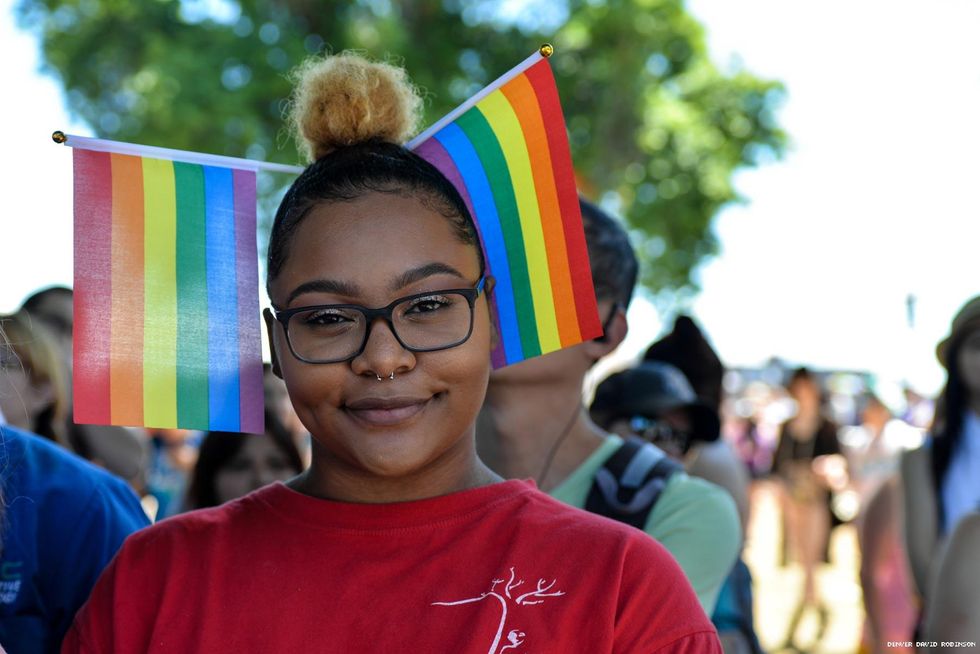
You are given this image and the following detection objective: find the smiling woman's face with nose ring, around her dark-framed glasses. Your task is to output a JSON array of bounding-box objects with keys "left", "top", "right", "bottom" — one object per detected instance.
[{"left": 270, "top": 193, "right": 491, "bottom": 480}]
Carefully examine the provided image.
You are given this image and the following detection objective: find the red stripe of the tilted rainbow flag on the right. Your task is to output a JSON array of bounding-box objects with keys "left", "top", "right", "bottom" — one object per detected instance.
[{"left": 524, "top": 59, "right": 602, "bottom": 340}]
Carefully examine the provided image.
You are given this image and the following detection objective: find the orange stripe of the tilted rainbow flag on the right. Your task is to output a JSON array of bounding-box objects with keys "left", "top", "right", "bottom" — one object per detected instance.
[{"left": 501, "top": 75, "right": 582, "bottom": 347}]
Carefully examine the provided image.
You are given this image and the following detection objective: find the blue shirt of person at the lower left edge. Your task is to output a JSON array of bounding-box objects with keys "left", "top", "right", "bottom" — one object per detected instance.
[{"left": 0, "top": 425, "right": 149, "bottom": 654}]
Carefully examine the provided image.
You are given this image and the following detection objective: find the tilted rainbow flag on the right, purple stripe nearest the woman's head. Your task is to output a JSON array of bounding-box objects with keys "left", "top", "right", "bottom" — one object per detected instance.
[{"left": 407, "top": 46, "right": 602, "bottom": 367}]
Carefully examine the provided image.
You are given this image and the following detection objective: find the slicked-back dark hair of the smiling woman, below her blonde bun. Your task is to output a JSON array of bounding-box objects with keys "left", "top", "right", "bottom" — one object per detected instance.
[{"left": 267, "top": 140, "right": 486, "bottom": 298}]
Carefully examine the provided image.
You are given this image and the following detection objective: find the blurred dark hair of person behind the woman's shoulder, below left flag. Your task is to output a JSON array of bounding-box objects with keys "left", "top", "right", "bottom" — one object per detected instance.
[{"left": 185, "top": 411, "right": 303, "bottom": 510}]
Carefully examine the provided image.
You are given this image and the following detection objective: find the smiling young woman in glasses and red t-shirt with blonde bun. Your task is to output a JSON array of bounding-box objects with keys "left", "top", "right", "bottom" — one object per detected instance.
[{"left": 64, "top": 55, "right": 720, "bottom": 654}]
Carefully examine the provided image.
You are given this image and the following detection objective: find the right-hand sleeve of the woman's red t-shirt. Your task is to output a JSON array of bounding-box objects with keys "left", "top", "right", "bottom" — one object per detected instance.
[{"left": 613, "top": 534, "right": 722, "bottom": 654}]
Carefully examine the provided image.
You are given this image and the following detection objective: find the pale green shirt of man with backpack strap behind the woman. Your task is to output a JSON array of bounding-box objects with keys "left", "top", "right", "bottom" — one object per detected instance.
[{"left": 550, "top": 435, "right": 742, "bottom": 615}]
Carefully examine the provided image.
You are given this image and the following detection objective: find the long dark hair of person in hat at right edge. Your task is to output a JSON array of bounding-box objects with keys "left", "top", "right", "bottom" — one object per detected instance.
[{"left": 929, "top": 338, "right": 969, "bottom": 530}]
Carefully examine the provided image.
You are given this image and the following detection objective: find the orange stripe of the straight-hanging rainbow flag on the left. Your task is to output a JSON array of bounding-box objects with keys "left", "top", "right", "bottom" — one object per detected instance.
[{"left": 109, "top": 154, "right": 144, "bottom": 426}]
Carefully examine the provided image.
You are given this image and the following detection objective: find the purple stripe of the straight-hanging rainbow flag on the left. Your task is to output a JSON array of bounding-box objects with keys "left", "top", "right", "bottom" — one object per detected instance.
[{"left": 233, "top": 170, "right": 265, "bottom": 434}]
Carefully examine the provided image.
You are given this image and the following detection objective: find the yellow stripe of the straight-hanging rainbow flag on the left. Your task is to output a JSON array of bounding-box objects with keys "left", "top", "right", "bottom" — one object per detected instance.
[{"left": 143, "top": 158, "right": 177, "bottom": 427}]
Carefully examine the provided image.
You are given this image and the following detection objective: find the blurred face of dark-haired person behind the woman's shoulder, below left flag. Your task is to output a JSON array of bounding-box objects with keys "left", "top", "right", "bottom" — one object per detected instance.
[{"left": 214, "top": 434, "right": 299, "bottom": 504}]
